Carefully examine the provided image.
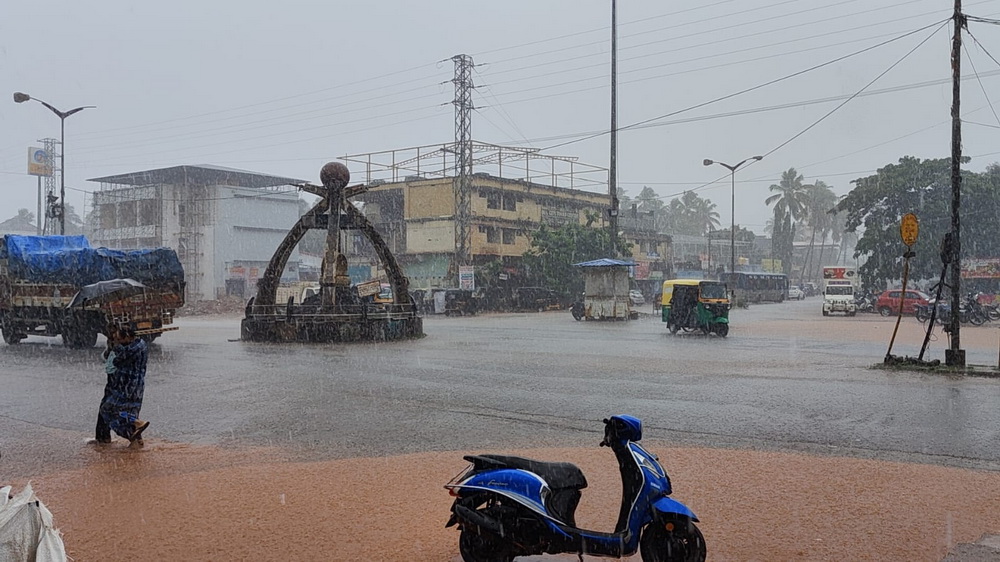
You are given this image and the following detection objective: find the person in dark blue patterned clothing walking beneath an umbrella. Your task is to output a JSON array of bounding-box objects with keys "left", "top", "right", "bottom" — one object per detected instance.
[{"left": 95, "top": 324, "right": 149, "bottom": 447}]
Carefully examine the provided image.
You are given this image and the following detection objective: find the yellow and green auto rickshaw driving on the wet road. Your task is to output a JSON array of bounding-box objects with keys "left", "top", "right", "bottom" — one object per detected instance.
[{"left": 660, "top": 279, "right": 729, "bottom": 337}]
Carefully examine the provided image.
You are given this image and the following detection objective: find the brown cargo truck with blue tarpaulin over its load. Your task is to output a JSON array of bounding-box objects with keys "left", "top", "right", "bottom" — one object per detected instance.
[{"left": 0, "top": 234, "right": 184, "bottom": 348}]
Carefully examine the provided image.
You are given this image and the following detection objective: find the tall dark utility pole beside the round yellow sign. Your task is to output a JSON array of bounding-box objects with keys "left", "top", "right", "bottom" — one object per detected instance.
[{"left": 945, "top": 0, "right": 965, "bottom": 367}]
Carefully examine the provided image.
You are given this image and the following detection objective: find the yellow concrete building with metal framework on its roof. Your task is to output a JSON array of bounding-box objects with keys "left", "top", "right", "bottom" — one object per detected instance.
[{"left": 344, "top": 142, "right": 670, "bottom": 288}]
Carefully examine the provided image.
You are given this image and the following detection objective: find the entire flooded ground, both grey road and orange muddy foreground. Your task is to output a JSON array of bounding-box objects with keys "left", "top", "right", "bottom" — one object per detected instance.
[{"left": 0, "top": 299, "right": 1000, "bottom": 562}]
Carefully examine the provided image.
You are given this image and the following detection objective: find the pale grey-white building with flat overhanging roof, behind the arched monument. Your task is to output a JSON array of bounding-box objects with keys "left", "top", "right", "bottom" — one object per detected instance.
[{"left": 89, "top": 165, "right": 306, "bottom": 301}]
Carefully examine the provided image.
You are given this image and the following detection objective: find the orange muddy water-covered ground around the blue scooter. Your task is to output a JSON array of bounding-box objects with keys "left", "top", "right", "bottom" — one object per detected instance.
[{"left": 11, "top": 441, "right": 1000, "bottom": 562}]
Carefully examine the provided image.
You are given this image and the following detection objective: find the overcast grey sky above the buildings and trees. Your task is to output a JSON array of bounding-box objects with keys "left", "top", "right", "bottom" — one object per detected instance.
[{"left": 0, "top": 0, "right": 1000, "bottom": 232}]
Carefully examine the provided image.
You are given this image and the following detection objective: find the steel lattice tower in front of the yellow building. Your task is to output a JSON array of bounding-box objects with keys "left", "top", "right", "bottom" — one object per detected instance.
[{"left": 451, "top": 55, "right": 475, "bottom": 278}]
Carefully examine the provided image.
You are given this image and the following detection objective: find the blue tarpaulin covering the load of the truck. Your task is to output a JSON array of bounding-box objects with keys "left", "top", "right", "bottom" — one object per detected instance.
[{"left": 0, "top": 234, "right": 184, "bottom": 286}]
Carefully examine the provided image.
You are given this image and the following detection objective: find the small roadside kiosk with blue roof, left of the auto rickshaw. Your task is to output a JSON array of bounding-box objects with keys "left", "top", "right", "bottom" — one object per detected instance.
[{"left": 573, "top": 258, "right": 638, "bottom": 320}]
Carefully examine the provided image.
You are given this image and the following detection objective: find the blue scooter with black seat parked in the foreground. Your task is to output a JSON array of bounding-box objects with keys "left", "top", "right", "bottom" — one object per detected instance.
[{"left": 445, "top": 415, "right": 706, "bottom": 562}]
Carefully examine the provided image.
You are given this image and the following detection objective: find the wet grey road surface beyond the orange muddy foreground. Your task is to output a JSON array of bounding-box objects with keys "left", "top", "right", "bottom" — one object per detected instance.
[{"left": 0, "top": 299, "right": 1000, "bottom": 475}]
